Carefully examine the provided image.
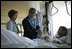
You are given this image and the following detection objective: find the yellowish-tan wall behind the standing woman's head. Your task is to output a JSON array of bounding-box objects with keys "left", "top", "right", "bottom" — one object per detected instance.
[{"left": 1, "top": 1, "right": 29, "bottom": 24}]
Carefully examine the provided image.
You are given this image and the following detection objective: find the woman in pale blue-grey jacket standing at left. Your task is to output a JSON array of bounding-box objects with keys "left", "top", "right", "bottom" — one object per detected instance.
[{"left": 6, "top": 9, "right": 19, "bottom": 34}]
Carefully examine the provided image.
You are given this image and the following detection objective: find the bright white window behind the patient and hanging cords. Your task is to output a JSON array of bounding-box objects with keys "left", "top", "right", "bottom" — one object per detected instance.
[{"left": 48, "top": 1, "right": 71, "bottom": 36}]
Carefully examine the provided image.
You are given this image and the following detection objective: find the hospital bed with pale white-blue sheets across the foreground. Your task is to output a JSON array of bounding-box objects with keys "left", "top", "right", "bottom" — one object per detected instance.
[{"left": 1, "top": 28, "right": 71, "bottom": 48}]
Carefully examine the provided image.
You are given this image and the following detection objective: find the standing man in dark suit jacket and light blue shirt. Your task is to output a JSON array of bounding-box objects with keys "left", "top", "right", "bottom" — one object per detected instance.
[{"left": 22, "top": 8, "right": 41, "bottom": 39}]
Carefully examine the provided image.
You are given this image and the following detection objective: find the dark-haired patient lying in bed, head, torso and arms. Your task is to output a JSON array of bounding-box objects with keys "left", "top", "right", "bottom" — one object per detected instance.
[{"left": 40, "top": 26, "right": 70, "bottom": 44}]
